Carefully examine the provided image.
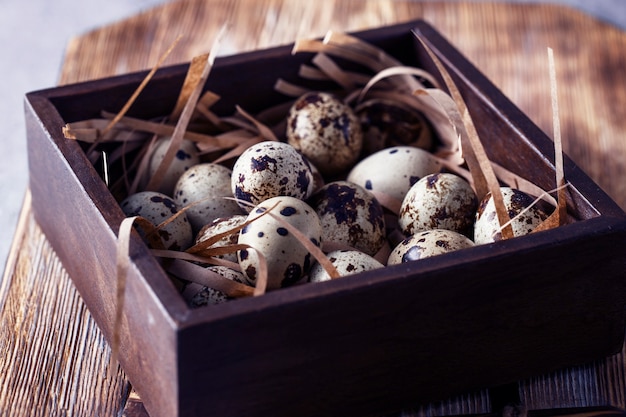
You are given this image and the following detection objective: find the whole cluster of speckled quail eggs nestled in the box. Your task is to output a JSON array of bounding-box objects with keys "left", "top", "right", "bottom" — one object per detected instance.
[{"left": 121, "top": 92, "right": 545, "bottom": 306}]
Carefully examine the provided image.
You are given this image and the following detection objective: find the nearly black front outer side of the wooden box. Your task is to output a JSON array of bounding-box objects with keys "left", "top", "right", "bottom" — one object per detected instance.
[{"left": 174, "top": 218, "right": 626, "bottom": 417}]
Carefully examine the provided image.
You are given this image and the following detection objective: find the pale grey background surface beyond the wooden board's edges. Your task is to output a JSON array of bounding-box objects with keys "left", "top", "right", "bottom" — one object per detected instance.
[{"left": 0, "top": 0, "right": 626, "bottom": 279}]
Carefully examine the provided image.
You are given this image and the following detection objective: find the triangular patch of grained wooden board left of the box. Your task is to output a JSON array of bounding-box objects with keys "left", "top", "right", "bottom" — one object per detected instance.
[{"left": 0, "top": 191, "right": 130, "bottom": 416}]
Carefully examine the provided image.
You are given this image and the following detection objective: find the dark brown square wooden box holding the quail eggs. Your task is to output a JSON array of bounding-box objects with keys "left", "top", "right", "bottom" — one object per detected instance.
[{"left": 26, "top": 21, "right": 626, "bottom": 417}]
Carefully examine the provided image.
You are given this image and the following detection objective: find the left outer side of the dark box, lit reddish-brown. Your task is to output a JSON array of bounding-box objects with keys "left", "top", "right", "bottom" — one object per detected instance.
[{"left": 26, "top": 97, "right": 177, "bottom": 416}]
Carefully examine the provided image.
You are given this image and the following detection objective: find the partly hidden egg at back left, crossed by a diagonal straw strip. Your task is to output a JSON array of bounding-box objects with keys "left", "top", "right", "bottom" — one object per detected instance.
[{"left": 148, "top": 137, "right": 200, "bottom": 196}]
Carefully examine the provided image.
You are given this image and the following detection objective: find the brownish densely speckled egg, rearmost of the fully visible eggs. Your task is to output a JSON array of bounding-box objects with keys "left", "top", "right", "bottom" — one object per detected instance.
[{"left": 286, "top": 91, "right": 363, "bottom": 176}]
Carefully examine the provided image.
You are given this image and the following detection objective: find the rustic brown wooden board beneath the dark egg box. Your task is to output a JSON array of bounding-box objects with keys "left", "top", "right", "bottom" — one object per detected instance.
[{"left": 0, "top": 0, "right": 626, "bottom": 417}]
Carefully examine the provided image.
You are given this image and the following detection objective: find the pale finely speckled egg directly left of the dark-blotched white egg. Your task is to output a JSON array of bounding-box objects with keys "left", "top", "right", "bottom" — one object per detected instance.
[{"left": 174, "top": 163, "right": 242, "bottom": 232}]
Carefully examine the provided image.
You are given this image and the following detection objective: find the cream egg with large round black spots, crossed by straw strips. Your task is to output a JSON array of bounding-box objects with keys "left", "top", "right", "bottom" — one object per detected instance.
[{"left": 237, "top": 196, "right": 322, "bottom": 290}]
